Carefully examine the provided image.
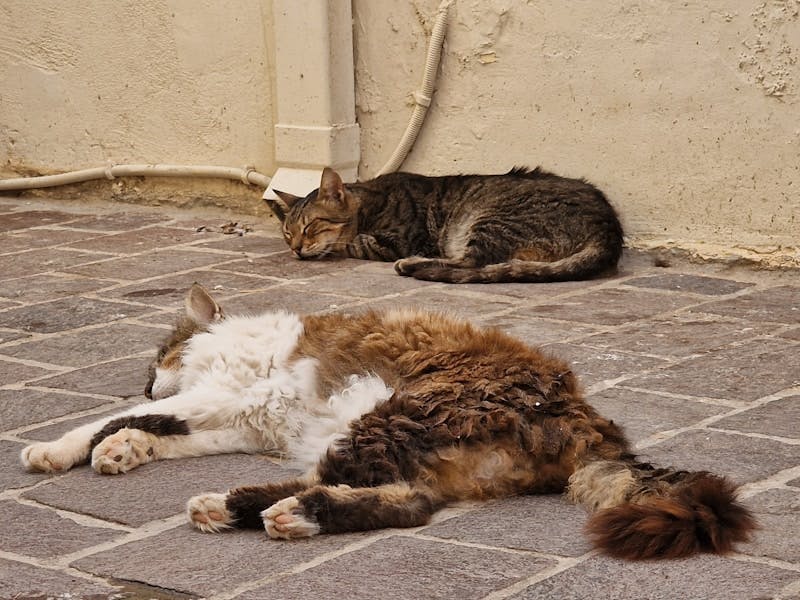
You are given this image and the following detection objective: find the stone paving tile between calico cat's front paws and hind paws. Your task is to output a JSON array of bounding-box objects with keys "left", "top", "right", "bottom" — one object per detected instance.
[{"left": 24, "top": 454, "right": 298, "bottom": 526}]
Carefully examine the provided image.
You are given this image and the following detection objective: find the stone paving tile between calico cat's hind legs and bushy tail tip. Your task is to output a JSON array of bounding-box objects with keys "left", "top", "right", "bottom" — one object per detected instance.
[{"left": 421, "top": 495, "right": 592, "bottom": 556}]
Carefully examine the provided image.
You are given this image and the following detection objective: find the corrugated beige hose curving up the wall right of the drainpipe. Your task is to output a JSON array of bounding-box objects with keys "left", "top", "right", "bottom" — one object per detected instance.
[{"left": 378, "top": 0, "right": 453, "bottom": 175}]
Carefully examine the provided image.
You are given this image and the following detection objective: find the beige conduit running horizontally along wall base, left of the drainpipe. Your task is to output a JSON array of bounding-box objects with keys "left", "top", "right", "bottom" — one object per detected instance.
[{"left": 0, "top": 165, "right": 269, "bottom": 192}]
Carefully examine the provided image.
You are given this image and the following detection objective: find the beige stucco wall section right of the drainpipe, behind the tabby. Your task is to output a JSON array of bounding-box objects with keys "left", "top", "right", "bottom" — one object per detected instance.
[{"left": 354, "top": 0, "right": 800, "bottom": 262}]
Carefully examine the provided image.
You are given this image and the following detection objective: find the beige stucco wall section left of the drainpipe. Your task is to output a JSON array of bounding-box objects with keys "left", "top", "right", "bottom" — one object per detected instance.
[{"left": 0, "top": 0, "right": 274, "bottom": 174}]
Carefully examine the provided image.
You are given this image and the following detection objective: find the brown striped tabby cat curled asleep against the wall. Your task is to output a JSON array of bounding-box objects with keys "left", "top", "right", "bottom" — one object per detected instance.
[{"left": 267, "top": 168, "right": 622, "bottom": 283}]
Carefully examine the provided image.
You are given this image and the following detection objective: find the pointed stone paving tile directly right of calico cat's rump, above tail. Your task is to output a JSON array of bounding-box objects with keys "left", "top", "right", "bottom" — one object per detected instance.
[{"left": 589, "top": 387, "right": 730, "bottom": 442}]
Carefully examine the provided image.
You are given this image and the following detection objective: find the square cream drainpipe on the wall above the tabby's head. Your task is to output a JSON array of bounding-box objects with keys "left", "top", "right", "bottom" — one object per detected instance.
[{"left": 264, "top": 0, "right": 361, "bottom": 198}]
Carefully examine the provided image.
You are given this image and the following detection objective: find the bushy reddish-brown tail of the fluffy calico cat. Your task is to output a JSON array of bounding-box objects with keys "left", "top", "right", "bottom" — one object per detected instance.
[{"left": 567, "top": 460, "right": 757, "bottom": 560}]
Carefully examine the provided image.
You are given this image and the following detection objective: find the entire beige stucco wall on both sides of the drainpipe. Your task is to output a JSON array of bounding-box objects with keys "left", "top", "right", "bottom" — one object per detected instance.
[{"left": 0, "top": 0, "right": 800, "bottom": 263}]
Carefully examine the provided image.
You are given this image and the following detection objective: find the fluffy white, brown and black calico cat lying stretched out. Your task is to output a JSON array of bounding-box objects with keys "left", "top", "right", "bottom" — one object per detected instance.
[{"left": 22, "top": 284, "right": 755, "bottom": 559}]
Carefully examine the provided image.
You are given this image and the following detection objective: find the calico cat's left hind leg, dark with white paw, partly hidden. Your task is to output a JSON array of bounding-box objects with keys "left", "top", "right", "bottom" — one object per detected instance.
[{"left": 186, "top": 476, "right": 316, "bottom": 532}]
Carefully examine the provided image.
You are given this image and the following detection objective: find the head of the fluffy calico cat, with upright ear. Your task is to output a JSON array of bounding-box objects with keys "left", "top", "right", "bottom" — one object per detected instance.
[{"left": 144, "top": 283, "right": 225, "bottom": 400}]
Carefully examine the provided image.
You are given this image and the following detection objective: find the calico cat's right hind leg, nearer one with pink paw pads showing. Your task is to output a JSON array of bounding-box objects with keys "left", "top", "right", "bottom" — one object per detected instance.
[{"left": 263, "top": 482, "right": 445, "bottom": 539}]
